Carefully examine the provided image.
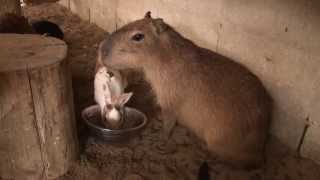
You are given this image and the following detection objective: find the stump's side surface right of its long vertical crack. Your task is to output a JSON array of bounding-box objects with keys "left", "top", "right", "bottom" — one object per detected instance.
[{"left": 29, "top": 63, "right": 78, "bottom": 179}]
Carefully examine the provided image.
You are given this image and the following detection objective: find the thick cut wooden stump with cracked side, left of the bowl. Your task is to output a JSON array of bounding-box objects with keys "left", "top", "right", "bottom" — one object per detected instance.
[{"left": 0, "top": 34, "right": 78, "bottom": 180}]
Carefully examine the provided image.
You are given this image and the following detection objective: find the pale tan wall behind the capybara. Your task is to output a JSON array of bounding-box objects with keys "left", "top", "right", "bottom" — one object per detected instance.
[{"left": 61, "top": 0, "right": 320, "bottom": 162}]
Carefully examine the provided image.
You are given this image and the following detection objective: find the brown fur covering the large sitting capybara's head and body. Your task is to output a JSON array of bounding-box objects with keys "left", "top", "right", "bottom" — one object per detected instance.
[{"left": 99, "top": 13, "right": 271, "bottom": 167}]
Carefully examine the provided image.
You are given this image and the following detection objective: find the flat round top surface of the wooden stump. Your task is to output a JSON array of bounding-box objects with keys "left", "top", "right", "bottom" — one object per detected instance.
[{"left": 0, "top": 34, "right": 67, "bottom": 72}]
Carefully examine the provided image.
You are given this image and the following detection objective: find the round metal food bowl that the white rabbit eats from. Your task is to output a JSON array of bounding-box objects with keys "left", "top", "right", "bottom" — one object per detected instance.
[{"left": 82, "top": 105, "right": 147, "bottom": 142}]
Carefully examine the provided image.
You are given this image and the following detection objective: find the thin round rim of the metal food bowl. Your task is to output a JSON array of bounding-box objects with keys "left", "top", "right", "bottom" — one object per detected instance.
[{"left": 81, "top": 105, "right": 148, "bottom": 134}]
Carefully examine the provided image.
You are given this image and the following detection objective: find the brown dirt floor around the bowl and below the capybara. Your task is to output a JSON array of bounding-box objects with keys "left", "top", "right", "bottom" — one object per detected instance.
[{"left": 24, "top": 4, "right": 320, "bottom": 180}]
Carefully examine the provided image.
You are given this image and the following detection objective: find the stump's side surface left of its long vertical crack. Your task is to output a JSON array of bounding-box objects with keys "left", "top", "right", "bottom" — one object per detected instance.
[{"left": 0, "top": 71, "right": 42, "bottom": 179}]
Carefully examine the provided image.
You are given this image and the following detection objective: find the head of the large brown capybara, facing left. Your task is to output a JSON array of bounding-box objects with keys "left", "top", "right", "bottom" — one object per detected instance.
[{"left": 99, "top": 12, "right": 169, "bottom": 69}]
